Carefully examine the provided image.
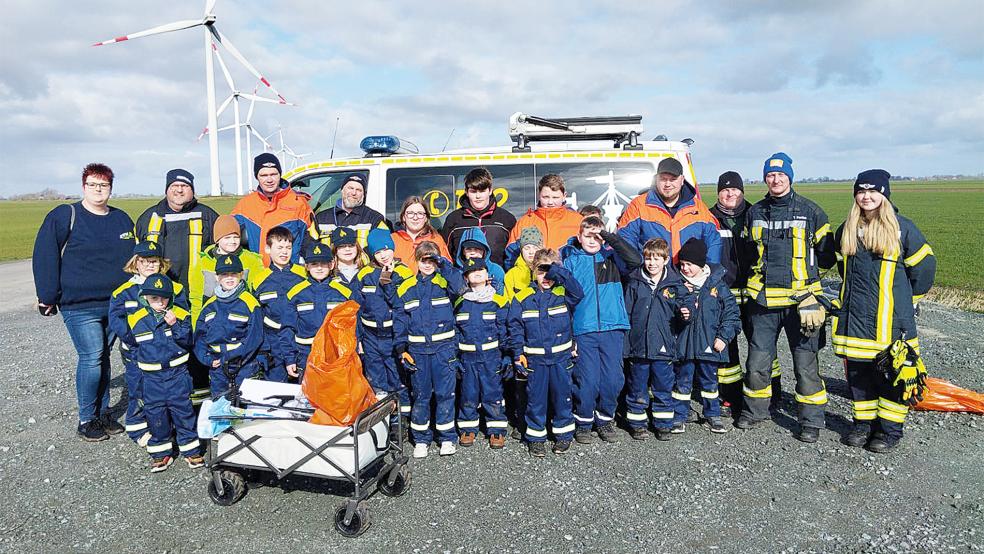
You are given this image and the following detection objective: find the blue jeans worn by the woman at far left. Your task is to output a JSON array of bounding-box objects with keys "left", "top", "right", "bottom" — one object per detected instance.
[{"left": 61, "top": 307, "right": 116, "bottom": 423}]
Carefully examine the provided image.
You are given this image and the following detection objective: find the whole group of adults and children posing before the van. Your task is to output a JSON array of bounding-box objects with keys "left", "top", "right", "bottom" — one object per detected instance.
[{"left": 33, "top": 152, "right": 935, "bottom": 471}]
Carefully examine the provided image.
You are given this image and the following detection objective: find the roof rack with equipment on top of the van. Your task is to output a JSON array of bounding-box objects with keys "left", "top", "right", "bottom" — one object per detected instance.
[{"left": 509, "top": 112, "right": 642, "bottom": 152}]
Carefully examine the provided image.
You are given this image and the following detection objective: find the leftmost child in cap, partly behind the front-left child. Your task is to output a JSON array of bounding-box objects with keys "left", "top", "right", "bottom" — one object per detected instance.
[{"left": 109, "top": 241, "right": 189, "bottom": 448}]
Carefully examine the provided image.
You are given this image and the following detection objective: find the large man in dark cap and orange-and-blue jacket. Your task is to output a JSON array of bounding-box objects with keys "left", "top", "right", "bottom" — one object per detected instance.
[{"left": 618, "top": 158, "right": 721, "bottom": 264}]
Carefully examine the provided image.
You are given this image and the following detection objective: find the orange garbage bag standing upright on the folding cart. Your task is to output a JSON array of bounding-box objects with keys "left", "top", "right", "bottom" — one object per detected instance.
[{"left": 301, "top": 300, "right": 376, "bottom": 425}]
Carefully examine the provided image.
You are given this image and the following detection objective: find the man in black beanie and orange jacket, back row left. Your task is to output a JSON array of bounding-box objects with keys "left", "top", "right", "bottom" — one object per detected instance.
[{"left": 232, "top": 152, "right": 317, "bottom": 266}]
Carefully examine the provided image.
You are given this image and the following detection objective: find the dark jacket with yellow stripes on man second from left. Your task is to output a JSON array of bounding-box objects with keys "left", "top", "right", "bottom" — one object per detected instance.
[{"left": 137, "top": 198, "right": 219, "bottom": 288}]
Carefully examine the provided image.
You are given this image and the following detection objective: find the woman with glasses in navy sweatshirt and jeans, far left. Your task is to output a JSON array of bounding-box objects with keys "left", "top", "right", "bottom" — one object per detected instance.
[{"left": 33, "top": 164, "right": 134, "bottom": 442}]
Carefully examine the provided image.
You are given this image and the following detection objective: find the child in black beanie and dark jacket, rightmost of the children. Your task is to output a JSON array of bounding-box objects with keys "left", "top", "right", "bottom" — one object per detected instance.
[{"left": 671, "top": 238, "right": 741, "bottom": 433}]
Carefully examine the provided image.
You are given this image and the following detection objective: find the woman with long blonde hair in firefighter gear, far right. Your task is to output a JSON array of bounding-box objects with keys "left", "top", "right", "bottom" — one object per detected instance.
[{"left": 833, "top": 169, "right": 936, "bottom": 452}]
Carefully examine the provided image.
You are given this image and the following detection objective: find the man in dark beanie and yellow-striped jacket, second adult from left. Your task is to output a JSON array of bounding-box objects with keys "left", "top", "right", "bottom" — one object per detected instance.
[{"left": 137, "top": 169, "right": 219, "bottom": 288}]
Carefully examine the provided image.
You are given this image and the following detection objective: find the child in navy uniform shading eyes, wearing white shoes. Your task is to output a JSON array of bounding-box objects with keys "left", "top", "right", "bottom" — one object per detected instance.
[{"left": 393, "top": 240, "right": 465, "bottom": 458}]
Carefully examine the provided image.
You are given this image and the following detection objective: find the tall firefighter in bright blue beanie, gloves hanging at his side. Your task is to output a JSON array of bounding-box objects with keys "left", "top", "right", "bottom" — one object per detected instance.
[{"left": 735, "top": 152, "right": 834, "bottom": 443}]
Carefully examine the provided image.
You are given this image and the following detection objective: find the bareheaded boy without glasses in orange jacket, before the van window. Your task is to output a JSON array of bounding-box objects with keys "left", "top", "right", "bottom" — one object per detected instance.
[{"left": 505, "top": 173, "right": 583, "bottom": 268}]
